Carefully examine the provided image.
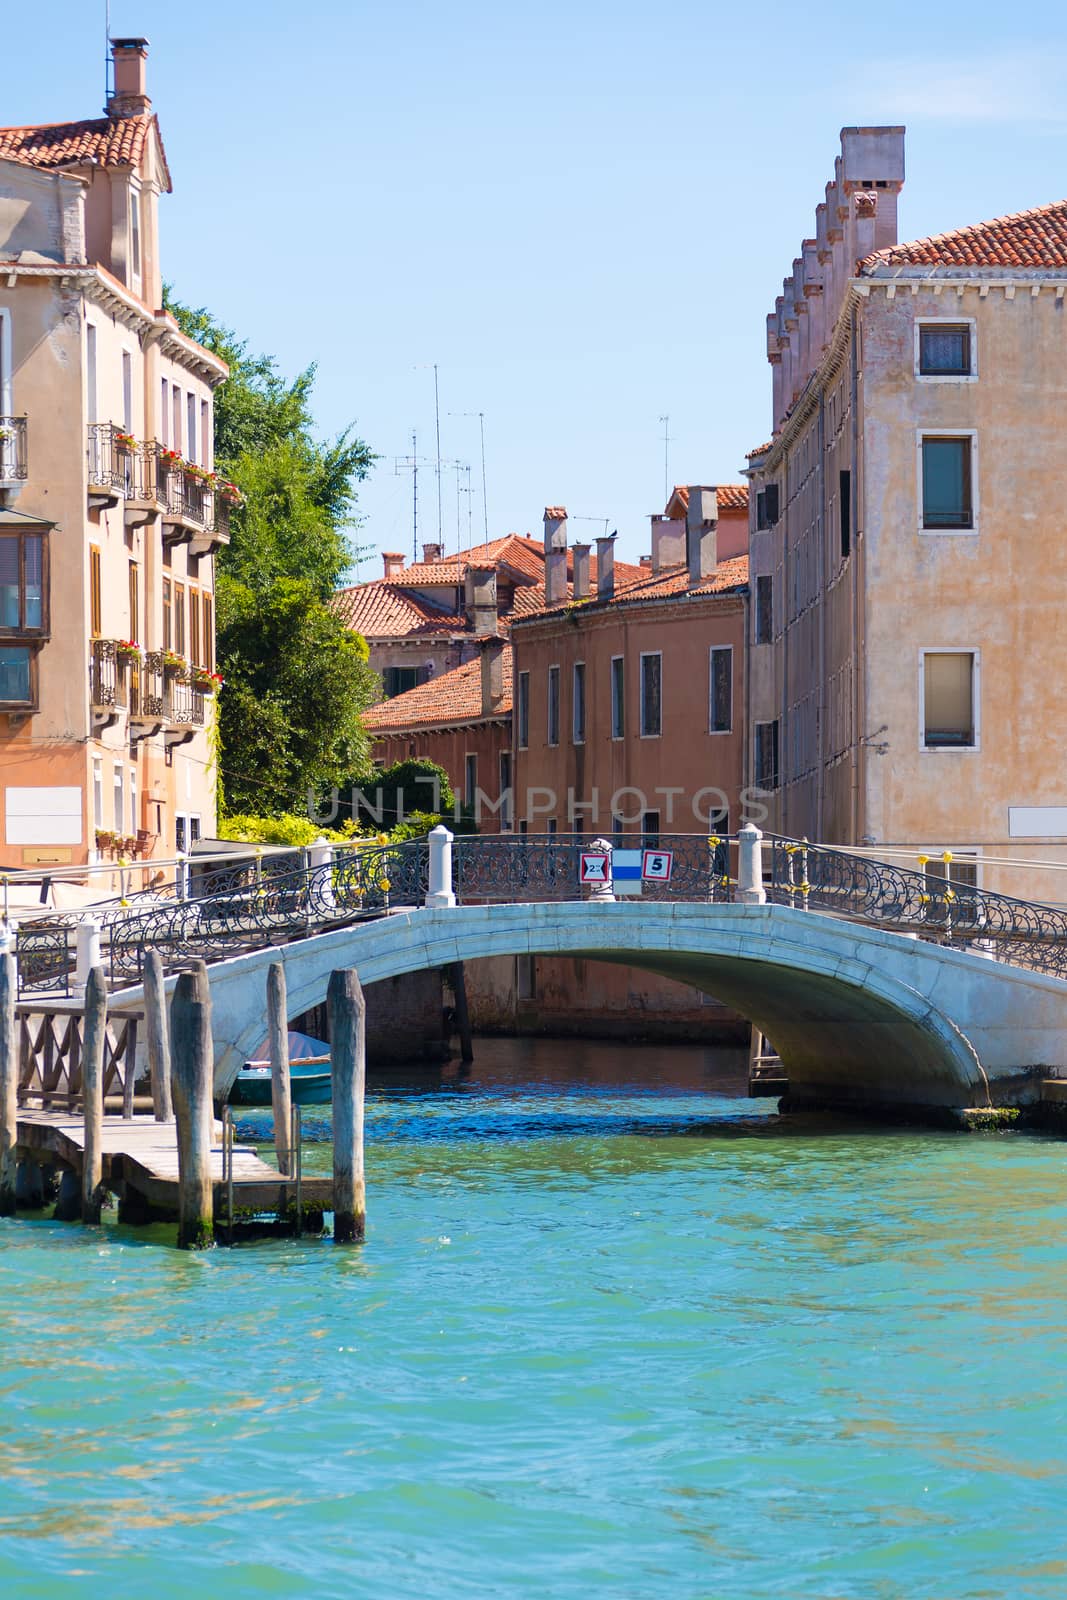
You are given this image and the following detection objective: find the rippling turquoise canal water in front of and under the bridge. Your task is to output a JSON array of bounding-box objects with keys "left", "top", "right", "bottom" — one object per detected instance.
[{"left": 0, "top": 1042, "right": 1067, "bottom": 1600}]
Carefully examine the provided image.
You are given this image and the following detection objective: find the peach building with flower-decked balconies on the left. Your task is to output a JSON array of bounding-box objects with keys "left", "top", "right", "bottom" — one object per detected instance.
[{"left": 0, "top": 38, "right": 230, "bottom": 867}]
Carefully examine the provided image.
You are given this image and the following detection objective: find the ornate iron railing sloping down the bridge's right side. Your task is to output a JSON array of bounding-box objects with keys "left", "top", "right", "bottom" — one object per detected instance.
[{"left": 763, "top": 838, "right": 1067, "bottom": 978}]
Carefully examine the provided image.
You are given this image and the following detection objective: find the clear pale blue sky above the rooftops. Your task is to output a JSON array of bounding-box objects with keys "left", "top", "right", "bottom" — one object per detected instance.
[{"left": 8, "top": 0, "right": 1067, "bottom": 576}]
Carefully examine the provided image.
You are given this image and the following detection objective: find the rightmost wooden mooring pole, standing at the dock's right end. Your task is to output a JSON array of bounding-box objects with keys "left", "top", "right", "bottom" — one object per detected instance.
[{"left": 326, "top": 968, "right": 366, "bottom": 1245}]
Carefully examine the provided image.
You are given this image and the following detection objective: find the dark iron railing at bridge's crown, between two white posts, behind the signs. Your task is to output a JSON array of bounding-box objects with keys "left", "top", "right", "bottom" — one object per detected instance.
[{"left": 453, "top": 834, "right": 731, "bottom": 904}]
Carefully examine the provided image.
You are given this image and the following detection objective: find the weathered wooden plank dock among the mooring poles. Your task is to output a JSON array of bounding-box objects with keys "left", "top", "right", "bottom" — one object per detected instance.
[{"left": 18, "top": 1107, "right": 333, "bottom": 1218}]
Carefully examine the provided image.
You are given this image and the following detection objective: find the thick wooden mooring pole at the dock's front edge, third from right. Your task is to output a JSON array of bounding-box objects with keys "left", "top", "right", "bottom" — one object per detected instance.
[{"left": 171, "top": 962, "right": 214, "bottom": 1250}]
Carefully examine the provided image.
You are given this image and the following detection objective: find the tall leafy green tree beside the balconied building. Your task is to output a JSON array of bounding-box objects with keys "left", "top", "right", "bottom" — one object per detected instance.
[{"left": 166, "top": 291, "right": 381, "bottom": 816}]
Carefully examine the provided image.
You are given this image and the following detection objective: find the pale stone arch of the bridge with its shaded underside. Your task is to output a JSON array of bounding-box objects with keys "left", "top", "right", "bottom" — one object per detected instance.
[{"left": 211, "top": 901, "right": 990, "bottom": 1107}]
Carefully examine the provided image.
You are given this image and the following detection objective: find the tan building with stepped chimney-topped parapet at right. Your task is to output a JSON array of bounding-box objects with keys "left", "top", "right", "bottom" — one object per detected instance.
[{"left": 750, "top": 128, "right": 1067, "bottom": 901}]
